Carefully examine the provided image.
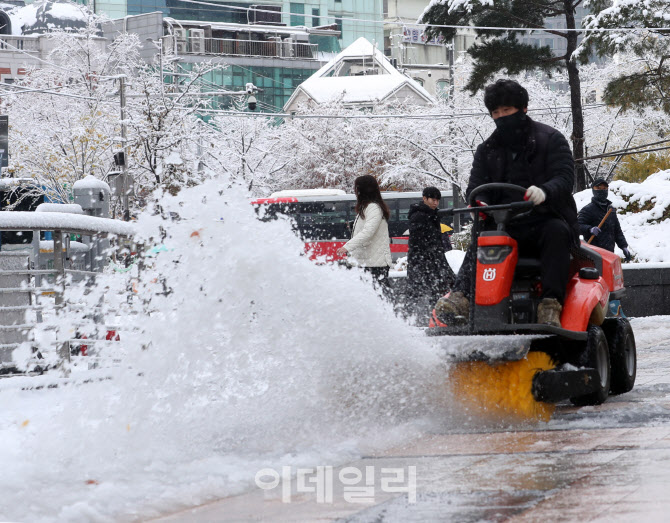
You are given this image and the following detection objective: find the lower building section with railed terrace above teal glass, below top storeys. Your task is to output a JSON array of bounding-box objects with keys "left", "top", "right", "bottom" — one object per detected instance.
[{"left": 103, "top": 12, "right": 339, "bottom": 112}]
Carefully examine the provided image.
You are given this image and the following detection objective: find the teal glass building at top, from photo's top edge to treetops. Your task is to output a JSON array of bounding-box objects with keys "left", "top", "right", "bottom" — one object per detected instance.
[{"left": 90, "top": 0, "right": 383, "bottom": 111}]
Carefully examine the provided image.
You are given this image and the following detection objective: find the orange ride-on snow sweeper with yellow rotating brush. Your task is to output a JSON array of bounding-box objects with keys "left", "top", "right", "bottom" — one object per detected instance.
[{"left": 427, "top": 183, "right": 637, "bottom": 421}]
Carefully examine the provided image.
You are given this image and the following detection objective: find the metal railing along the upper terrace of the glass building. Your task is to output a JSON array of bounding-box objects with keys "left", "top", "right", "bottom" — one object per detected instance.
[{"left": 184, "top": 38, "right": 318, "bottom": 60}]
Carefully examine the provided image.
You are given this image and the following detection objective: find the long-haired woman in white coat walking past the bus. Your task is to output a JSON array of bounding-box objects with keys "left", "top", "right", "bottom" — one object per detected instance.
[{"left": 337, "top": 174, "right": 391, "bottom": 288}]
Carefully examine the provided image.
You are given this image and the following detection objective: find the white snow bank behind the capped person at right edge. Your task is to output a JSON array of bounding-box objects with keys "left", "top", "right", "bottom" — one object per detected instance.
[{"left": 575, "top": 171, "right": 670, "bottom": 262}]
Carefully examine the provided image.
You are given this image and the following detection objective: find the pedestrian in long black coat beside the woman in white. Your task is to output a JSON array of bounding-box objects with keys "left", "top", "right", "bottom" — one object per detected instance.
[{"left": 407, "top": 187, "right": 456, "bottom": 321}]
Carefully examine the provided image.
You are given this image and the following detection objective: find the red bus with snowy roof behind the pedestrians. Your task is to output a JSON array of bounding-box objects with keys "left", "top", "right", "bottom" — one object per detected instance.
[{"left": 251, "top": 189, "right": 462, "bottom": 261}]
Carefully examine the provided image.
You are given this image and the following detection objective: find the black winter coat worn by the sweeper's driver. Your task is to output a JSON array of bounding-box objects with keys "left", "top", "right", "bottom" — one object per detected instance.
[{"left": 466, "top": 117, "right": 579, "bottom": 243}]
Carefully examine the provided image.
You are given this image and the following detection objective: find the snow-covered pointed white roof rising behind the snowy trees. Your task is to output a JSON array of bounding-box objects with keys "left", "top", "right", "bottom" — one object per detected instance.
[{"left": 284, "top": 38, "right": 435, "bottom": 112}]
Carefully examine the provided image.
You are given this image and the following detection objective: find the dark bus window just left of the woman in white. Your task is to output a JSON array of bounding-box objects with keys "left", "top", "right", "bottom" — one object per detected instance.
[{"left": 298, "top": 202, "right": 351, "bottom": 240}]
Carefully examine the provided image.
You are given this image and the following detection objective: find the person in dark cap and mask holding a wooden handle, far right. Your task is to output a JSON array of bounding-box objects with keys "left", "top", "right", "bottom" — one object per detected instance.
[{"left": 577, "top": 178, "right": 632, "bottom": 261}]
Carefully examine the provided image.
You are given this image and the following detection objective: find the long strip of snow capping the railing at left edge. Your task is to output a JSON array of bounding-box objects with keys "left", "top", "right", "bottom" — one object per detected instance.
[{"left": 0, "top": 211, "right": 136, "bottom": 236}]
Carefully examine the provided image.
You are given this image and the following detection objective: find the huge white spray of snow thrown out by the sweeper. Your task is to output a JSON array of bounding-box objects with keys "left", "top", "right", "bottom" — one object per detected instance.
[{"left": 0, "top": 182, "right": 444, "bottom": 521}]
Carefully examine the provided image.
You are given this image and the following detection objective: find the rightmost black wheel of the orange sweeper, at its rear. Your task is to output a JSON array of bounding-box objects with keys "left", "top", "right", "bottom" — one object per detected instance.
[{"left": 603, "top": 318, "right": 637, "bottom": 394}]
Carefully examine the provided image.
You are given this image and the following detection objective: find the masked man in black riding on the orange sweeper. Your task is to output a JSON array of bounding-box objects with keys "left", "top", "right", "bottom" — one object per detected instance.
[{"left": 435, "top": 79, "right": 579, "bottom": 327}]
